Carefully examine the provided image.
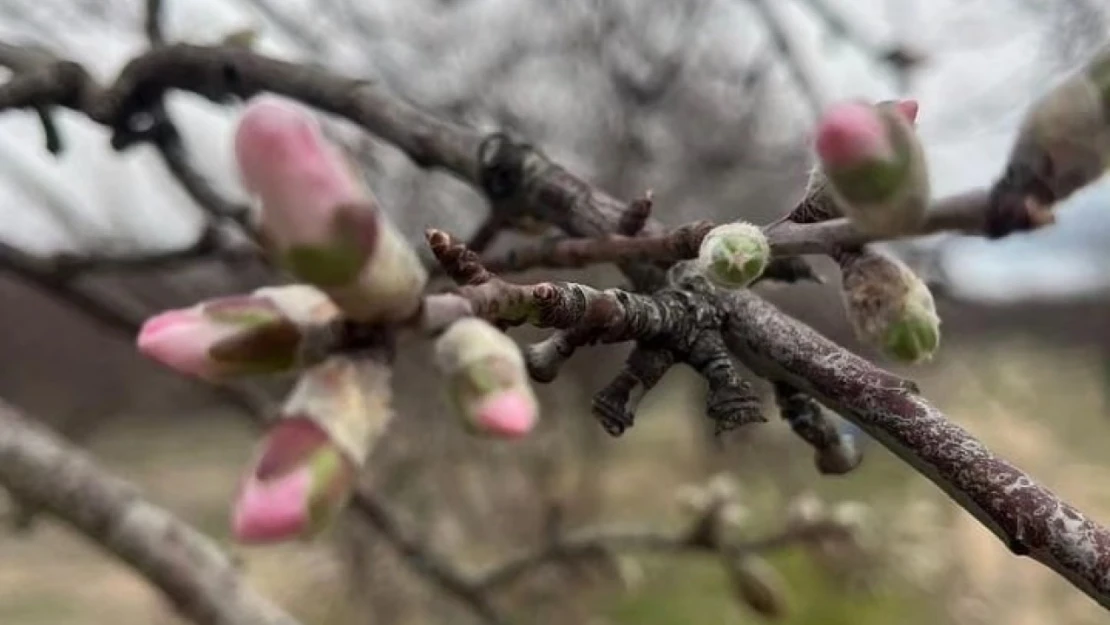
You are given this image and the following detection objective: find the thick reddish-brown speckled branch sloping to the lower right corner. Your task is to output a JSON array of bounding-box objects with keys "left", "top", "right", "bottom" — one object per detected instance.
[{"left": 723, "top": 292, "right": 1110, "bottom": 607}]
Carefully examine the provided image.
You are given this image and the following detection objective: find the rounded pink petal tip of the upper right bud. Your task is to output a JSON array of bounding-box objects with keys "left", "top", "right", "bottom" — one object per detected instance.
[{"left": 817, "top": 102, "right": 890, "bottom": 168}]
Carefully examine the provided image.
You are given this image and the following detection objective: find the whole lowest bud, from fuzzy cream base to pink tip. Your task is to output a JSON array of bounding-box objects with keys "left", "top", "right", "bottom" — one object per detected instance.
[{"left": 232, "top": 356, "right": 392, "bottom": 543}]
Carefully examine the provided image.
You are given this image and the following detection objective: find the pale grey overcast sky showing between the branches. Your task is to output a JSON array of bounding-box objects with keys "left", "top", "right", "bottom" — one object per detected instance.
[{"left": 0, "top": 0, "right": 1110, "bottom": 299}]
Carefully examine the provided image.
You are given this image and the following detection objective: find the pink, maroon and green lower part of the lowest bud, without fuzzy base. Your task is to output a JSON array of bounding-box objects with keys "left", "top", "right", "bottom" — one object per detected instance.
[{"left": 232, "top": 419, "right": 356, "bottom": 543}]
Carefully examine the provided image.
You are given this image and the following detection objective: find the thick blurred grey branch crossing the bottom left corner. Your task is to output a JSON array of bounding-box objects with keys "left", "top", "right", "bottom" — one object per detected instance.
[{"left": 0, "top": 402, "right": 296, "bottom": 625}]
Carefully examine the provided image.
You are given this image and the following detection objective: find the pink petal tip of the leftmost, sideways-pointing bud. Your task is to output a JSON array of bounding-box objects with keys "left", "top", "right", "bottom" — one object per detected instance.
[{"left": 137, "top": 310, "right": 222, "bottom": 379}]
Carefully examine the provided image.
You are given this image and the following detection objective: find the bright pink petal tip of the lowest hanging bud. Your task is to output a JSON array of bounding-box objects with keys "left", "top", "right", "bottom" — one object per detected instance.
[{"left": 231, "top": 467, "right": 312, "bottom": 543}]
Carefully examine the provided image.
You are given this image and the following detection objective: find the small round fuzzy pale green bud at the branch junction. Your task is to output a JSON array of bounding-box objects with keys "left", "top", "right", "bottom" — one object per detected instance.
[{"left": 698, "top": 222, "right": 770, "bottom": 289}]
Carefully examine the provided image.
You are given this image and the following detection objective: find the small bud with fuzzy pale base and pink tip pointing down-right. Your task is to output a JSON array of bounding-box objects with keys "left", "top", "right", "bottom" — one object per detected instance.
[{"left": 435, "top": 317, "right": 539, "bottom": 438}]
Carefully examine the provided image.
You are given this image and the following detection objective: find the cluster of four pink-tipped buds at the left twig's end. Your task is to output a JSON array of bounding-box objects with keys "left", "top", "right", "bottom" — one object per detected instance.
[{"left": 138, "top": 98, "right": 536, "bottom": 543}]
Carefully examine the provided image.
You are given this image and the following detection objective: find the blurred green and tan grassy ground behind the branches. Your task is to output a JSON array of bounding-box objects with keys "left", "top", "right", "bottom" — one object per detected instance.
[{"left": 0, "top": 343, "right": 1110, "bottom": 625}]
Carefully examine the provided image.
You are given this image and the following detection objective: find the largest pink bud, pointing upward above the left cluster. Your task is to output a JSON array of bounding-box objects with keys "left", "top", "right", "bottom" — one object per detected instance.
[{"left": 235, "top": 97, "right": 427, "bottom": 322}]
